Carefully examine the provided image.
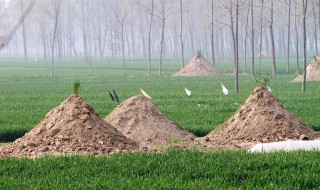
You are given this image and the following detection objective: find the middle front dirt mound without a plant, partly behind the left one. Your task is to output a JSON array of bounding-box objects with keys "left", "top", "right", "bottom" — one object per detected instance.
[{"left": 105, "top": 96, "right": 194, "bottom": 145}]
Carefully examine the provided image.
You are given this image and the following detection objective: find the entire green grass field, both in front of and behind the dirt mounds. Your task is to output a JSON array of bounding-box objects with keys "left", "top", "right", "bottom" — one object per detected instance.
[{"left": 0, "top": 60, "right": 320, "bottom": 189}]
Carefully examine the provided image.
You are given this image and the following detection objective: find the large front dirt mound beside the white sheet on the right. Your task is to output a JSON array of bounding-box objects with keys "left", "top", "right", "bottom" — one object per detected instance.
[{"left": 201, "top": 88, "right": 320, "bottom": 148}]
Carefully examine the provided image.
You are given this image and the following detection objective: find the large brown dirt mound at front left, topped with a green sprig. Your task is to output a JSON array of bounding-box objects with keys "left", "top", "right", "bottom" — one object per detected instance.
[{"left": 0, "top": 96, "right": 138, "bottom": 157}]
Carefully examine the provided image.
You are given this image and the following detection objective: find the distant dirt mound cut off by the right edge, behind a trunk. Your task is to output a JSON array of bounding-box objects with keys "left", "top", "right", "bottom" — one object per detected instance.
[{"left": 292, "top": 56, "right": 320, "bottom": 82}]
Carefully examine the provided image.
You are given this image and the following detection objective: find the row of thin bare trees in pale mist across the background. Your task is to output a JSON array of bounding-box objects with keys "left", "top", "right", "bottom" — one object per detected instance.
[{"left": 0, "top": 0, "right": 320, "bottom": 79}]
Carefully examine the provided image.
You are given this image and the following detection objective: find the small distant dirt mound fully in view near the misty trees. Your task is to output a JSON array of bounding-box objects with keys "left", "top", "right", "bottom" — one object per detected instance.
[{"left": 173, "top": 55, "right": 221, "bottom": 76}]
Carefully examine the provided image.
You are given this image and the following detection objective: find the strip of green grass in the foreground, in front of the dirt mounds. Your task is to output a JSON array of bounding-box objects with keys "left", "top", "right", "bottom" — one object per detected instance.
[{"left": 0, "top": 150, "right": 320, "bottom": 189}]
